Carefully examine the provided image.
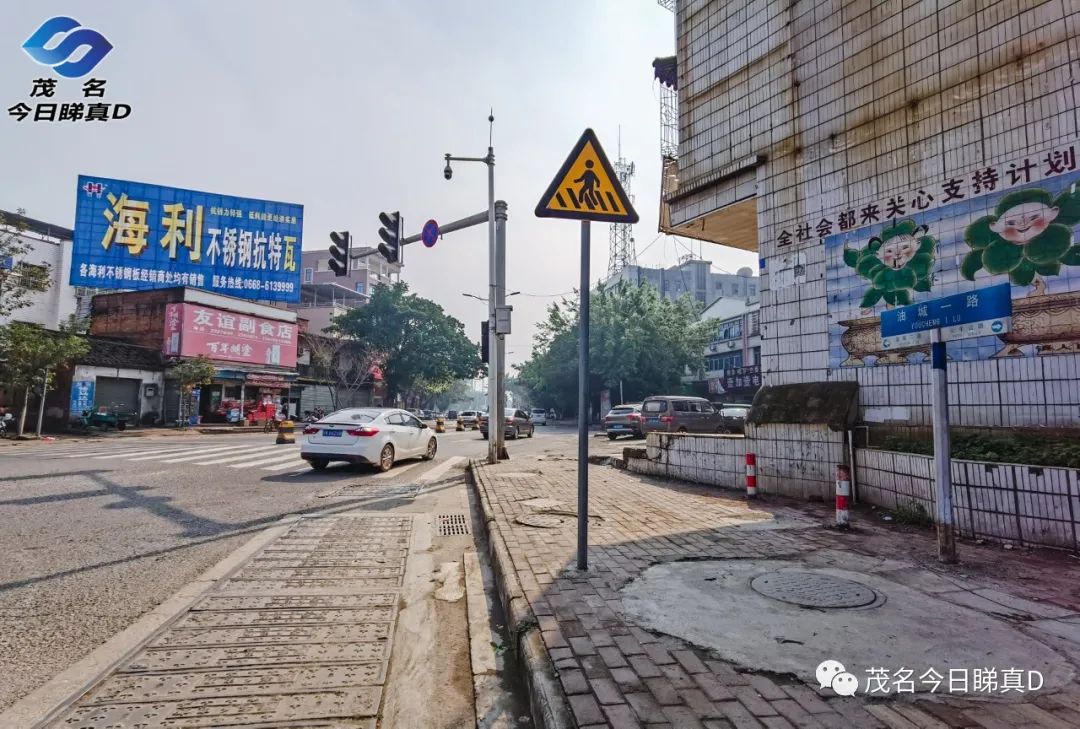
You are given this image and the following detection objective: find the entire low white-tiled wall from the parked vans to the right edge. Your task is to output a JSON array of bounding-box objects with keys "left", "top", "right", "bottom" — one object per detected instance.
[{"left": 625, "top": 434, "right": 1080, "bottom": 552}]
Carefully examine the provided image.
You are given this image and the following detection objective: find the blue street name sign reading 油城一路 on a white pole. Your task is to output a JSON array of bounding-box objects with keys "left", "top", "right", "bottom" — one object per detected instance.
[{"left": 881, "top": 283, "right": 1012, "bottom": 349}]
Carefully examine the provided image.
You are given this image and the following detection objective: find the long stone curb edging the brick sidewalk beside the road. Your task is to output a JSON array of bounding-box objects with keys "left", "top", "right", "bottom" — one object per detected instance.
[{"left": 469, "top": 459, "right": 577, "bottom": 729}]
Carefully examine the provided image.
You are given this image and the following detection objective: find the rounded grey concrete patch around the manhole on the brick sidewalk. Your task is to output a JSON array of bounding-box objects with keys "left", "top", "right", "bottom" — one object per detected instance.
[{"left": 621, "top": 559, "right": 1076, "bottom": 701}]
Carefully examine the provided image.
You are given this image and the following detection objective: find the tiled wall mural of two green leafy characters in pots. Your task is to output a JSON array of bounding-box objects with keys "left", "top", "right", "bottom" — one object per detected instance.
[{"left": 825, "top": 172, "right": 1080, "bottom": 367}]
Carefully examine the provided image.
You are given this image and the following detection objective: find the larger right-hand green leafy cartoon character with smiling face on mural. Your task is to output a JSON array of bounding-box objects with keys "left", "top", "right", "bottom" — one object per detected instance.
[{"left": 960, "top": 189, "right": 1080, "bottom": 296}]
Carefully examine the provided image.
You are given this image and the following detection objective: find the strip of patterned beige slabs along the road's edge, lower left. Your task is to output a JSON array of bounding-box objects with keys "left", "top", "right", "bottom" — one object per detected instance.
[{"left": 50, "top": 515, "right": 413, "bottom": 729}]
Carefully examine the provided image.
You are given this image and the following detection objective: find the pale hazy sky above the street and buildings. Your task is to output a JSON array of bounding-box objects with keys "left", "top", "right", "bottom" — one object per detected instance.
[{"left": 0, "top": 0, "right": 755, "bottom": 364}]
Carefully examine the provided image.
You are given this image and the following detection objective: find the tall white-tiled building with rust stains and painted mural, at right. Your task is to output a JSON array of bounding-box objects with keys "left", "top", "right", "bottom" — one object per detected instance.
[{"left": 661, "top": 0, "right": 1080, "bottom": 429}]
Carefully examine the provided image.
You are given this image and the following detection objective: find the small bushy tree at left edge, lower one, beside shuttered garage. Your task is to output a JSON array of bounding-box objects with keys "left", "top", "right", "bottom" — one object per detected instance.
[{"left": 0, "top": 322, "right": 90, "bottom": 435}]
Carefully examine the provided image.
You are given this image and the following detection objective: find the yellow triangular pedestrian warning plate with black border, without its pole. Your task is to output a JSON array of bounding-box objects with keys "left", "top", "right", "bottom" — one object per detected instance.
[{"left": 536, "top": 130, "right": 638, "bottom": 222}]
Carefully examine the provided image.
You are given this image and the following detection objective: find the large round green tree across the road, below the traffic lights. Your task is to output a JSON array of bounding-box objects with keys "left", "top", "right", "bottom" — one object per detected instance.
[{"left": 327, "top": 283, "right": 484, "bottom": 402}]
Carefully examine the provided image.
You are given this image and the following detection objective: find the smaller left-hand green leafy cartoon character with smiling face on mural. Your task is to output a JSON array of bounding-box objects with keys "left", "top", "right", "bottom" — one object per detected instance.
[{"left": 843, "top": 220, "right": 937, "bottom": 309}]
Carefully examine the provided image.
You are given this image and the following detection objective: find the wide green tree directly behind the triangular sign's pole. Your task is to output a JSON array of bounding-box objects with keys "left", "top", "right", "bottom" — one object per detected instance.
[{"left": 517, "top": 281, "right": 717, "bottom": 413}]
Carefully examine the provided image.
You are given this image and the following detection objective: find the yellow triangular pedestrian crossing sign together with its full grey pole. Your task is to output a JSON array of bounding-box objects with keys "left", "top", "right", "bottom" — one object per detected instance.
[{"left": 536, "top": 130, "right": 637, "bottom": 571}]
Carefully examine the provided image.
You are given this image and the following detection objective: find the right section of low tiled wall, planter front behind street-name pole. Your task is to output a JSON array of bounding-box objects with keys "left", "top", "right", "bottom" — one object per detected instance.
[{"left": 855, "top": 448, "right": 1080, "bottom": 552}]
